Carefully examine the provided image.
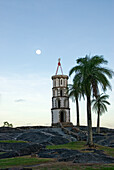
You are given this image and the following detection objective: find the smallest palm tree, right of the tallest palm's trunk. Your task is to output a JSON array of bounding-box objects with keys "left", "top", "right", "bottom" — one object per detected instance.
[{"left": 92, "top": 93, "right": 110, "bottom": 133}]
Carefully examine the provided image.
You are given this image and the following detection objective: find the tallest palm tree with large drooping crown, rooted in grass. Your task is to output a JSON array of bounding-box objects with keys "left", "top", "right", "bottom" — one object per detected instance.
[{"left": 69, "top": 55, "right": 114, "bottom": 146}]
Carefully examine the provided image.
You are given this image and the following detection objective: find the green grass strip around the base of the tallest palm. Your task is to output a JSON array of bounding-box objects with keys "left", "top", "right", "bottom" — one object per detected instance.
[{"left": 47, "top": 141, "right": 114, "bottom": 156}]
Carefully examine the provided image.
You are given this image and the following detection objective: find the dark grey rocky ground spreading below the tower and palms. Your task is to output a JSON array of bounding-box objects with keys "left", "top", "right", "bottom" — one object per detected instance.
[{"left": 0, "top": 126, "right": 114, "bottom": 163}]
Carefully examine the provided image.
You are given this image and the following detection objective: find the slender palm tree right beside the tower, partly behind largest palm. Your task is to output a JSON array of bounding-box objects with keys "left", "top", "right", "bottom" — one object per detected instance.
[{"left": 68, "top": 81, "right": 81, "bottom": 127}]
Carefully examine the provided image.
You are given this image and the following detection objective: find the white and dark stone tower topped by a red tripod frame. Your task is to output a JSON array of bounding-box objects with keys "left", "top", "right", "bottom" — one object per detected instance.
[{"left": 51, "top": 59, "right": 70, "bottom": 126}]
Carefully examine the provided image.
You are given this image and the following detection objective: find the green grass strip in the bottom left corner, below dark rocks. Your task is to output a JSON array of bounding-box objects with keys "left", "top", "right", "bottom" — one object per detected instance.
[{"left": 0, "top": 156, "right": 54, "bottom": 168}]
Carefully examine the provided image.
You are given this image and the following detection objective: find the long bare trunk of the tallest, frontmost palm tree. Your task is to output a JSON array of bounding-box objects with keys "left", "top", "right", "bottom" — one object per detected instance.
[{"left": 87, "top": 96, "right": 93, "bottom": 146}]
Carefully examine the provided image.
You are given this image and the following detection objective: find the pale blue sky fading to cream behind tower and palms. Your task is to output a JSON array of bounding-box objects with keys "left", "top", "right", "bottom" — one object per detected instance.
[{"left": 0, "top": 0, "right": 114, "bottom": 127}]
